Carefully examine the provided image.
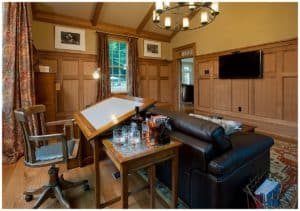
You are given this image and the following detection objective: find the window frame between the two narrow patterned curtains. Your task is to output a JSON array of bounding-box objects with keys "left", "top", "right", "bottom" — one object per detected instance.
[{"left": 108, "top": 35, "right": 129, "bottom": 95}]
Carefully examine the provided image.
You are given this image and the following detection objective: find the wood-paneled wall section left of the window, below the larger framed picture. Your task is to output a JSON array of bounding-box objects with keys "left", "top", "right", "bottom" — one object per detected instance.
[{"left": 39, "top": 51, "right": 97, "bottom": 119}]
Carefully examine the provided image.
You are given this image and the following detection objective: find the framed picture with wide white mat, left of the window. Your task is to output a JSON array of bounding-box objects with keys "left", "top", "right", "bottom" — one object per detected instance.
[{"left": 55, "top": 26, "right": 85, "bottom": 51}]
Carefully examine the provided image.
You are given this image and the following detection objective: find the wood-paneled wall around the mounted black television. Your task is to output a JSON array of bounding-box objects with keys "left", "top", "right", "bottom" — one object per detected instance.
[{"left": 195, "top": 39, "right": 298, "bottom": 139}]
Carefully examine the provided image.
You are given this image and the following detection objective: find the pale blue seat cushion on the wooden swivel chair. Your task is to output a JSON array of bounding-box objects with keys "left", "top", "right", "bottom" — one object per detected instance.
[{"left": 35, "top": 140, "right": 75, "bottom": 161}]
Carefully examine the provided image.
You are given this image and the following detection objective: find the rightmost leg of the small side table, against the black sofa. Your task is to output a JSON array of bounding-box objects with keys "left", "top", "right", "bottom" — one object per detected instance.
[{"left": 171, "top": 148, "right": 178, "bottom": 209}]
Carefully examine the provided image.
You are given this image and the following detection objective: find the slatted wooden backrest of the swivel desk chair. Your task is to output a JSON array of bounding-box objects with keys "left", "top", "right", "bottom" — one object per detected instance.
[{"left": 14, "top": 105, "right": 47, "bottom": 163}]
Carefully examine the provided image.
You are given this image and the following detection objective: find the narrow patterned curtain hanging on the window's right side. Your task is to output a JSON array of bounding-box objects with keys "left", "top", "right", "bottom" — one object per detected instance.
[{"left": 128, "top": 37, "right": 139, "bottom": 96}]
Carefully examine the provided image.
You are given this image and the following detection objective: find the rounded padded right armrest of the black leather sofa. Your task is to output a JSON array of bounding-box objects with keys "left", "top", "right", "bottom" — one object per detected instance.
[{"left": 208, "top": 132, "right": 274, "bottom": 175}]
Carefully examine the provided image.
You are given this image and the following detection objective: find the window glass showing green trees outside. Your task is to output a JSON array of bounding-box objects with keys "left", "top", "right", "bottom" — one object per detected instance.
[{"left": 108, "top": 40, "right": 128, "bottom": 93}]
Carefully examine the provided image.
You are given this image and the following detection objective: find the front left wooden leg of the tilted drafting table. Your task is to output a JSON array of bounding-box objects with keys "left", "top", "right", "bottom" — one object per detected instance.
[{"left": 92, "top": 139, "right": 101, "bottom": 208}]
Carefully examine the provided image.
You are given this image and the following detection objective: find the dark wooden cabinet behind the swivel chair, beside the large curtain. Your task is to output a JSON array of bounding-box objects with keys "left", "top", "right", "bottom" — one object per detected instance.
[{"left": 34, "top": 72, "right": 56, "bottom": 132}]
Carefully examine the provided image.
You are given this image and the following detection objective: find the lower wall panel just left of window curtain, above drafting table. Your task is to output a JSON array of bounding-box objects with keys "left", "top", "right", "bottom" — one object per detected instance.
[{"left": 83, "top": 80, "right": 98, "bottom": 108}]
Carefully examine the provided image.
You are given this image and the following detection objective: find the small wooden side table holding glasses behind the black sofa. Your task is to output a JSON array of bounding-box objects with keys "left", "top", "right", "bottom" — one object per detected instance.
[{"left": 101, "top": 139, "right": 182, "bottom": 208}]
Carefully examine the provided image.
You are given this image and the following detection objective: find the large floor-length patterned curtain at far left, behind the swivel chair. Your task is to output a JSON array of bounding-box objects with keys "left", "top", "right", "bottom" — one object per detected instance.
[{"left": 2, "top": 2, "right": 35, "bottom": 163}]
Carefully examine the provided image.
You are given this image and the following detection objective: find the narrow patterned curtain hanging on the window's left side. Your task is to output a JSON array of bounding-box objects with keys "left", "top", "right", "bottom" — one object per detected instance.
[{"left": 97, "top": 32, "right": 111, "bottom": 101}]
